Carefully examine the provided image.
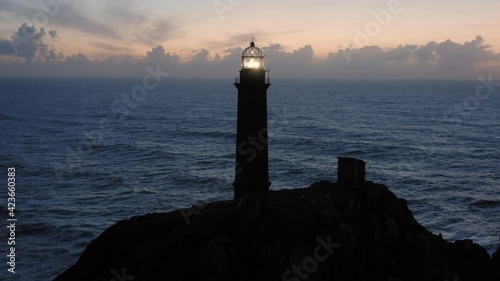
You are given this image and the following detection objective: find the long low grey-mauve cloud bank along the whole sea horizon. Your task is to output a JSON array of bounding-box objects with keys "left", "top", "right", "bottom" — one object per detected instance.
[{"left": 0, "top": 35, "right": 500, "bottom": 79}]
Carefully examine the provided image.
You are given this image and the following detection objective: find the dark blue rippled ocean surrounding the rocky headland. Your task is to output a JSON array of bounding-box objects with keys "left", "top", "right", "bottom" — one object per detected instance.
[{"left": 0, "top": 78, "right": 500, "bottom": 281}]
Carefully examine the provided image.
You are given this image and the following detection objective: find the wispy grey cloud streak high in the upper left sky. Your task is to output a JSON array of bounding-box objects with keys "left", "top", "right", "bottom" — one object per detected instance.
[{"left": 0, "top": 0, "right": 183, "bottom": 47}]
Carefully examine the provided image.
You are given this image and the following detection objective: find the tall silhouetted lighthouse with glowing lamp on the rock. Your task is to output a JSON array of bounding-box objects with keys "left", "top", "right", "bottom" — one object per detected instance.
[{"left": 233, "top": 40, "right": 271, "bottom": 210}]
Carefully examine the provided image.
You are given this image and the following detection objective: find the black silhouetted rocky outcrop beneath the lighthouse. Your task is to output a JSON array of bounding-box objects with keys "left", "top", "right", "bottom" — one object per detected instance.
[{"left": 55, "top": 179, "right": 500, "bottom": 281}]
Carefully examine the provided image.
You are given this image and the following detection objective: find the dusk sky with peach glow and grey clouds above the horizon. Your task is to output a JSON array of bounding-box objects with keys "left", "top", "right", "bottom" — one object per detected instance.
[{"left": 0, "top": 0, "right": 500, "bottom": 80}]
